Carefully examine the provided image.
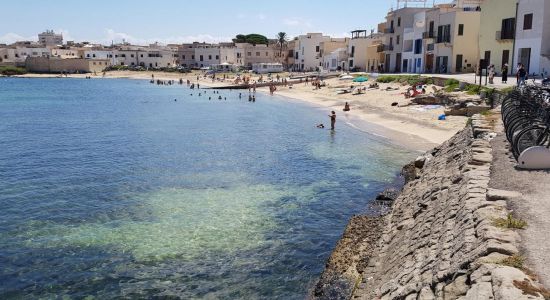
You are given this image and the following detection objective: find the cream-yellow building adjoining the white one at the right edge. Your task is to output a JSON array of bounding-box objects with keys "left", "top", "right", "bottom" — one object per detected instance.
[{"left": 479, "top": 0, "right": 517, "bottom": 74}]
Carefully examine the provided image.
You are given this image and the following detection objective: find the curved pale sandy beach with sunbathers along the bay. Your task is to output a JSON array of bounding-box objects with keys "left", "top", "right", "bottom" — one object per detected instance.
[{"left": 15, "top": 71, "right": 467, "bottom": 151}]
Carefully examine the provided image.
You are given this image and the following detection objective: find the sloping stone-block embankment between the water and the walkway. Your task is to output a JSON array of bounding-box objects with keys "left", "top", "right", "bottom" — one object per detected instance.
[{"left": 313, "top": 115, "right": 544, "bottom": 300}]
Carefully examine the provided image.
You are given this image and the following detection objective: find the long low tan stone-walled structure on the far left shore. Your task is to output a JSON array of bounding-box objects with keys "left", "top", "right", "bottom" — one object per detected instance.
[{"left": 25, "top": 57, "right": 110, "bottom": 73}]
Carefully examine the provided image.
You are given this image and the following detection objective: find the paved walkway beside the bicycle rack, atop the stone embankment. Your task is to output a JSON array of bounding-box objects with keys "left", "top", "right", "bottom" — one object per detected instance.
[{"left": 489, "top": 117, "right": 550, "bottom": 287}]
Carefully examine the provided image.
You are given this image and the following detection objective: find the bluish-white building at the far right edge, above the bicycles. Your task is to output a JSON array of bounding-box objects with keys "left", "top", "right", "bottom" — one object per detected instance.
[{"left": 513, "top": 0, "right": 550, "bottom": 75}]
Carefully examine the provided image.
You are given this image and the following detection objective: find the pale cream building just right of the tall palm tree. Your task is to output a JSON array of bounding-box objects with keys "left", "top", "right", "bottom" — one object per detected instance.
[{"left": 292, "top": 33, "right": 330, "bottom": 71}]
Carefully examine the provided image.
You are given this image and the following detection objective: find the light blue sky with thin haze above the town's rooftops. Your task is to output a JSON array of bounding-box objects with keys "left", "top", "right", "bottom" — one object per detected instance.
[{"left": 0, "top": 0, "right": 451, "bottom": 45}]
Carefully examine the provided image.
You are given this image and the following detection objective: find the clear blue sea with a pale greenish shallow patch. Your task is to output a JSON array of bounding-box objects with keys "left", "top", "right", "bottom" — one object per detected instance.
[{"left": 0, "top": 78, "right": 414, "bottom": 299}]
